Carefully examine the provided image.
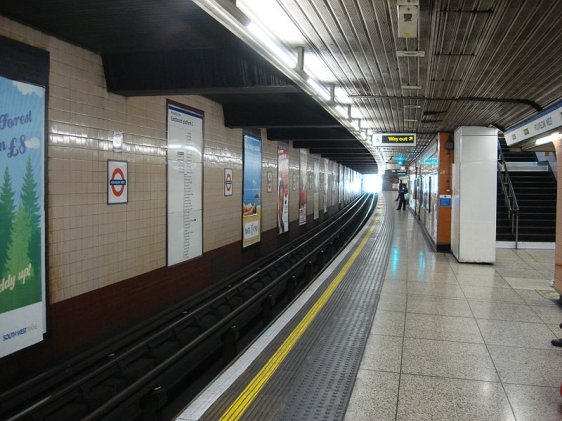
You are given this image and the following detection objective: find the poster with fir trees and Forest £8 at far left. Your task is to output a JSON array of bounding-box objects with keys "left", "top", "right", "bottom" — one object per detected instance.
[{"left": 0, "top": 77, "right": 46, "bottom": 357}]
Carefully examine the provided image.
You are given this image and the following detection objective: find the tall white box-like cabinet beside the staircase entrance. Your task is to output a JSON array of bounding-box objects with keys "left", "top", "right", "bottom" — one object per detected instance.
[{"left": 451, "top": 126, "right": 498, "bottom": 263}]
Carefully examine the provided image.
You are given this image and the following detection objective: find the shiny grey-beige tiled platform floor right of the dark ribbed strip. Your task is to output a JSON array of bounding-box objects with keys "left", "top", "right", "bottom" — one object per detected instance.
[{"left": 345, "top": 192, "right": 562, "bottom": 421}]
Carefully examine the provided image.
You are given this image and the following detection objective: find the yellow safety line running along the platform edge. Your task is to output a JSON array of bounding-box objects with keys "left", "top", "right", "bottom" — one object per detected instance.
[{"left": 220, "top": 218, "right": 376, "bottom": 421}]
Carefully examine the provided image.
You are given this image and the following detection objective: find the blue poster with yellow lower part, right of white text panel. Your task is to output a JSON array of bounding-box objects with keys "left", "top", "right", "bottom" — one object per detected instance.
[{"left": 242, "top": 135, "right": 262, "bottom": 247}]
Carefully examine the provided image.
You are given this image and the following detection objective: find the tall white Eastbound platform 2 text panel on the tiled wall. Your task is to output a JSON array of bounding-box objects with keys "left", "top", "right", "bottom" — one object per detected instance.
[{"left": 167, "top": 102, "right": 203, "bottom": 266}]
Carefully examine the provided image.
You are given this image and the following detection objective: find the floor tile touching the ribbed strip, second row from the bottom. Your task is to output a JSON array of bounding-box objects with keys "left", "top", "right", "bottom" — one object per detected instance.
[{"left": 360, "top": 335, "right": 403, "bottom": 373}]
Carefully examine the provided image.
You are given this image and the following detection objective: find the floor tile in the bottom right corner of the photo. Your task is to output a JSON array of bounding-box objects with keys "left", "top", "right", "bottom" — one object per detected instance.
[{"left": 505, "top": 384, "right": 562, "bottom": 421}]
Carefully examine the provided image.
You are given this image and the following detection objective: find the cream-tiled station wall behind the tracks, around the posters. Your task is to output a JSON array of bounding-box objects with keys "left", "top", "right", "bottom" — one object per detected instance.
[{"left": 0, "top": 16, "right": 356, "bottom": 376}]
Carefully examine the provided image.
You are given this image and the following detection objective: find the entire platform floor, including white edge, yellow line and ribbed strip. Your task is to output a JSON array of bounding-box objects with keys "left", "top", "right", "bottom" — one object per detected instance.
[{"left": 178, "top": 195, "right": 562, "bottom": 421}]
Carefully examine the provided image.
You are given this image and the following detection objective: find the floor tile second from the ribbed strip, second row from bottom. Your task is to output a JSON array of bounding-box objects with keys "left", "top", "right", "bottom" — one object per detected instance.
[{"left": 402, "top": 338, "right": 498, "bottom": 381}]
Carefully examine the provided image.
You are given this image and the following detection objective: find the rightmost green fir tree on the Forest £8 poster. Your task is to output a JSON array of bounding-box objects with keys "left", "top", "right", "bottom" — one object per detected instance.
[{"left": 21, "top": 157, "right": 41, "bottom": 279}]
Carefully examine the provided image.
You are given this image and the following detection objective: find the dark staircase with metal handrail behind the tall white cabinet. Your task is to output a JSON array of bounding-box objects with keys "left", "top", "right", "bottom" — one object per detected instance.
[{"left": 496, "top": 138, "right": 556, "bottom": 243}]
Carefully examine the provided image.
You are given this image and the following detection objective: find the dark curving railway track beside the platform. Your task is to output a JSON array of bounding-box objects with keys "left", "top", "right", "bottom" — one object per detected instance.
[{"left": 0, "top": 195, "right": 376, "bottom": 421}]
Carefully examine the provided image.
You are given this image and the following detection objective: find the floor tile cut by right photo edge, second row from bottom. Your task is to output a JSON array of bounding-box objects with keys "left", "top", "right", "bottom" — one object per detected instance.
[{"left": 488, "top": 345, "right": 562, "bottom": 387}]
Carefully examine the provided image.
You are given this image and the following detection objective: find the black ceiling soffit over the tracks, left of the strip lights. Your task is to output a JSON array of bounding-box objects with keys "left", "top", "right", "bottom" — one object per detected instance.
[{"left": 0, "top": 0, "right": 376, "bottom": 172}]
